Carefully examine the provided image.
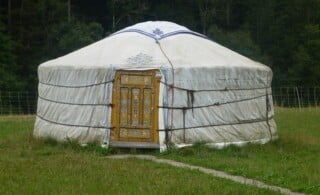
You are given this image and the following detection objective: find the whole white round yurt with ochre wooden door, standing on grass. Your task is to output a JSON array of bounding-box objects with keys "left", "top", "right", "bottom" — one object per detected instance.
[{"left": 34, "top": 21, "right": 277, "bottom": 149}]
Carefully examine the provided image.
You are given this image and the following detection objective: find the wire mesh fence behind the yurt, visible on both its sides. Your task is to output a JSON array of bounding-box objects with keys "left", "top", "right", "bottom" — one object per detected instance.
[{"left": 0, "top": 87, "right": 320, "bottom": 115}]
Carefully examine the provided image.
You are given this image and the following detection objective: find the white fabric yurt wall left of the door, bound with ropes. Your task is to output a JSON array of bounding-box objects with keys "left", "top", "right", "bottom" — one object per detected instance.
[{"left": 34, "top": 67, "right": 114, "bottom": 143}]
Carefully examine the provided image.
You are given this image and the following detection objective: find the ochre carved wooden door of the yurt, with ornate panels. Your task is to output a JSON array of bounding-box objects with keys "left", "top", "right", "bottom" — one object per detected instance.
[{"left": 111, "top": 70, "right": 159, "bottom": 142}]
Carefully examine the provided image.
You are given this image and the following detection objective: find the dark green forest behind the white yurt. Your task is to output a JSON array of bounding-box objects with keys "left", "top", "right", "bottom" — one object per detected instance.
[{"left": 0, "top": 0, "right": 320, "bottom": 92}]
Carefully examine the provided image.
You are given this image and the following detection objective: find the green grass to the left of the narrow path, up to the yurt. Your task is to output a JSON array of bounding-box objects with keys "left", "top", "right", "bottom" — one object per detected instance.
[{"left": 0, "top": 116, "right": 274, "bottom": 194}]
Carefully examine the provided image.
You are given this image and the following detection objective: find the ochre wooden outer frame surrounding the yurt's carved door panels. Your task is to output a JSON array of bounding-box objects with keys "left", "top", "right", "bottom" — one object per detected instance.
[{"left": 110, "top": 69, "right": 161, "bottom": 147}]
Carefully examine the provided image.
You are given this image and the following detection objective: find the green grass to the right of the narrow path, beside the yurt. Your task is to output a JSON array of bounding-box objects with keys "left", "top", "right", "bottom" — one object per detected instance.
[{"left": 160, "top": 108, "right": 320, "bottom": 194}]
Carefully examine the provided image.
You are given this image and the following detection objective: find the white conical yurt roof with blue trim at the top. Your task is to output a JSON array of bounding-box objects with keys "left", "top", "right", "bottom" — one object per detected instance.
[{"left": 40, "top": 21, "right": 269, "bottom": 70}]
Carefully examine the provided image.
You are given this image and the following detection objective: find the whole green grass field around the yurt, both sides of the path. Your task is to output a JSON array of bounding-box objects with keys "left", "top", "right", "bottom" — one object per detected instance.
[{"left": 0, "top": 108, "right": 320, "bottom": 194}]
